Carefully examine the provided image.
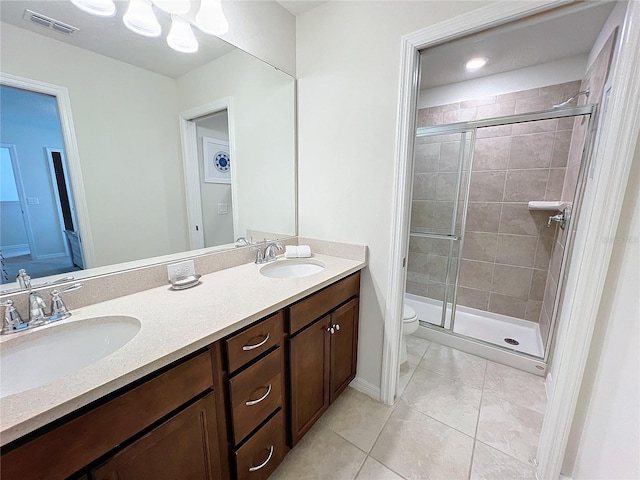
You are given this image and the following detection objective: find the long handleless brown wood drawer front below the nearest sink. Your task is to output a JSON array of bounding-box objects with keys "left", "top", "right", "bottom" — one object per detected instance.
[{"left": 1, "top": 351, "right": 213, "bottom": 480}]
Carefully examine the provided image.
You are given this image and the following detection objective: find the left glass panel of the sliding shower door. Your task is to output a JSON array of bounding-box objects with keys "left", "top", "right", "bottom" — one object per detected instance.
[{"left": 406, "top": 127, "right": 474, "bottom": 328}]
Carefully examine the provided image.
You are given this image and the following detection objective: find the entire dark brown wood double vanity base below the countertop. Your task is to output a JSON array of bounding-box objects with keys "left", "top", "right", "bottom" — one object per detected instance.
[{"left": 0, "top": 272, "right": 360, "bottom": 480}]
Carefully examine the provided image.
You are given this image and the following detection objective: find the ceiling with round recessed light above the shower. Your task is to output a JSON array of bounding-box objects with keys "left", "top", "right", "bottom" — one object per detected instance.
[{"left": 420, "top": 2, "right": 615, "bottom": 89}]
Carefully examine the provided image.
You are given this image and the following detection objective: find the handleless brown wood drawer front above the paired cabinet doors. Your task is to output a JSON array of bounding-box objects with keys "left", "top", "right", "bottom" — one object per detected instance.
[{"left": 289, "top": 272, "right": 360, "bottom": 334}]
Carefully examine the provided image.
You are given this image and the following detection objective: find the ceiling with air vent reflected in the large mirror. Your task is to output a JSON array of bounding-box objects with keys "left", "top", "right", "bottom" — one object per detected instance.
[{"left": 0, "top": 0, "right": 235, "bottom": 78}]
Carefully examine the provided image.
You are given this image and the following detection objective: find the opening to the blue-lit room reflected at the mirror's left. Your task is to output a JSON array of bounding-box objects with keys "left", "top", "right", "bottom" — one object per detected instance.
[{"left": 1, "top": 85, "right": 84, "bottom": 283}]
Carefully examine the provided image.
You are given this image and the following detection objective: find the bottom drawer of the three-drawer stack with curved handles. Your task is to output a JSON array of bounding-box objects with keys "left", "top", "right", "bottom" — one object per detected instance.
[{"left": 236, "top": 410, "right": 286, "bottom": 480}]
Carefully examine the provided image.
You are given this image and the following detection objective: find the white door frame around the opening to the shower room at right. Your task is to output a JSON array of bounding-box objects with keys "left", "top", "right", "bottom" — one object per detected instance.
[{"left": 381, "top": 0, "right": 640, "bottom": 479}]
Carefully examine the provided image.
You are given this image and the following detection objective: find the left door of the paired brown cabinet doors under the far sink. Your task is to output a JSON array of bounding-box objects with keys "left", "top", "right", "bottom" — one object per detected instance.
[{"left": 289, "top": 315, "right": 330, "bottom": 445}]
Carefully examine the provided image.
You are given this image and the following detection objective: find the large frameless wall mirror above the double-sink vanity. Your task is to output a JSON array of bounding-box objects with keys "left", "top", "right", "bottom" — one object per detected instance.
[{"left": 0, "top": 0, "right": 296, "bottom": 290}]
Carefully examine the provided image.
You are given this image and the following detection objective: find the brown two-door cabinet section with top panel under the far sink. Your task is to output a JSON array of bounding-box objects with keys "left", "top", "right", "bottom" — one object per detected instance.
[{"left": 289, "top": 273, "right": 360, "bottom": 446}]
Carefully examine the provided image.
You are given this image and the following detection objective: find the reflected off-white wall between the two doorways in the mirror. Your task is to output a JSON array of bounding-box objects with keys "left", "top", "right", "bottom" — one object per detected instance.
[{"left": 0, "top": 23, "right": 188, "bottom": 265}]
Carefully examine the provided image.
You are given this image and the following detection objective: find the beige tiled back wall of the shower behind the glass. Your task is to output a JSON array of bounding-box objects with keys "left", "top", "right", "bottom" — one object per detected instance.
[{"left": 407, "top": 81, "right": 580, "bottom": 322}]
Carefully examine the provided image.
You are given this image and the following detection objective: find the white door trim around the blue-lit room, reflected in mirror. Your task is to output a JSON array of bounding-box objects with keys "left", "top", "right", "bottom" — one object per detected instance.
[{"left": 0, "top": 72, "right": 96, "bottom": 268}]
